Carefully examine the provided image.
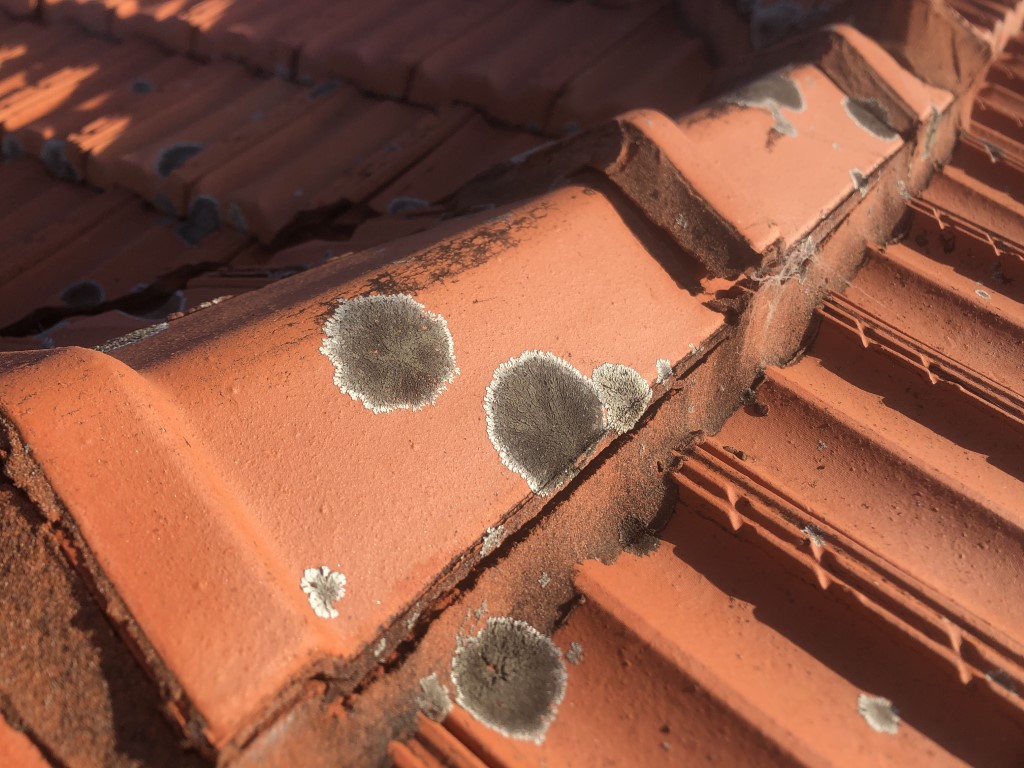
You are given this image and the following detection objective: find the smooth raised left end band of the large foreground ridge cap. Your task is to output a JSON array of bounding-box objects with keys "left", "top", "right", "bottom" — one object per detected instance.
[{"left": 0, "top": 347, "right": 330, "bottom": 744}]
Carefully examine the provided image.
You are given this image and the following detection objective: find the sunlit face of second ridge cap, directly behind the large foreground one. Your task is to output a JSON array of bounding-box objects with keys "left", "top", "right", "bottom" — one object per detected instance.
[{"left": 674, "top": 65, "right": 904, "bottom": 253}]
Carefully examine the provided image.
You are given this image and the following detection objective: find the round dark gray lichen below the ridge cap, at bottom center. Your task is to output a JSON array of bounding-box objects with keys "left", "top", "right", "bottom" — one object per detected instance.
[{"left": 452, "top": 616, "right": 566, "bottom": 743}]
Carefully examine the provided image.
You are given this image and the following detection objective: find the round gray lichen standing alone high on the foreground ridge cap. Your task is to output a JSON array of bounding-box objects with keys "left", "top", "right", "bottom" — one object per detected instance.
[{"left": 321, "top": 294, "right": 459, "bottom": 414}]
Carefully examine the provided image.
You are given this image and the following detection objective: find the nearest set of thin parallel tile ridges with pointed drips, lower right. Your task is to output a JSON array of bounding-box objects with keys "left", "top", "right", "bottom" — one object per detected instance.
[{"left": 673, "top": 448, "right": 1024, "bottom": 684}]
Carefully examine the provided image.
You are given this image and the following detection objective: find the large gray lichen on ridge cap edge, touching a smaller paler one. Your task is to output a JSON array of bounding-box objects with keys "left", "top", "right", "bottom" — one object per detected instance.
[{"left": 483, "top": 351, "right": 604, "bottom": 495}]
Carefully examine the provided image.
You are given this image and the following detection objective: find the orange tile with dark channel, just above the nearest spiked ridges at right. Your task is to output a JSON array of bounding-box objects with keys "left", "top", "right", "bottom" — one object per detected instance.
[{"left": 704, "top": 309, "right": 1024, "bottom": 647}]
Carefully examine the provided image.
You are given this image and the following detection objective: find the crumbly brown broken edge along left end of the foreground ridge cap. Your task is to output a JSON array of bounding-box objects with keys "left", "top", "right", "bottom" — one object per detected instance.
[{"left": 0, "top": 413, "right": 216, "bottom": 758}]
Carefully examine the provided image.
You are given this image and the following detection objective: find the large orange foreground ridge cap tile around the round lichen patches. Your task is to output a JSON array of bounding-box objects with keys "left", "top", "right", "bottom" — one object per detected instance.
[{"left": 0, "top": 186, "right": 723, "bottom": 757}]
